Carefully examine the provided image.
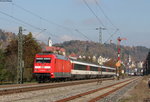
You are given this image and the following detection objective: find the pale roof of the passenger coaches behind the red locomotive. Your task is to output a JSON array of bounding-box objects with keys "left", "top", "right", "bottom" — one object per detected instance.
[{"left": 71, "top": 60, "right": 116, "bottom": 70}]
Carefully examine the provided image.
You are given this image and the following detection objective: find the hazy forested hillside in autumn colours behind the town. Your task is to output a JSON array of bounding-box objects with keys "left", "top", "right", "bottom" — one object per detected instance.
[{"left": 54, "top": 40, "right": 149, "bottom": 61}]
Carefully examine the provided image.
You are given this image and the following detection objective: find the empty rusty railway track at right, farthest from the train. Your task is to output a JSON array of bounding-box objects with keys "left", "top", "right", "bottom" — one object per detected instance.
[{"left": 56, "top": 78, "right": 141, "bottom": 102}]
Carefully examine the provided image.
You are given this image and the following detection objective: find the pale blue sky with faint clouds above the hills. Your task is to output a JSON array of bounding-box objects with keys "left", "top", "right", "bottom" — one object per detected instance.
[{"left": 0, "top": 0, "right": 150, "bottom": 48}]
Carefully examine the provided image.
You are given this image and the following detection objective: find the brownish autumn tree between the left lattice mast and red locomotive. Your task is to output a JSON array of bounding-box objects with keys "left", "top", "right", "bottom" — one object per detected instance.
[{"left": 23, "top": 32, "right": 42, "bottom": 81}]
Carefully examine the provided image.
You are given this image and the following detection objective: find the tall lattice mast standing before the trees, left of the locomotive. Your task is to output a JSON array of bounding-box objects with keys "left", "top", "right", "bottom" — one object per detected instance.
[{"left": 17, "top": 27, "right": 23, "bottom": 84}]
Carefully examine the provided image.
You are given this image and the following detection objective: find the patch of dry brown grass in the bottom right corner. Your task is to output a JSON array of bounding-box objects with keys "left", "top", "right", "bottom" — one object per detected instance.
[{"left": 119, "top": 76, "right": 150, "bottom": 102}]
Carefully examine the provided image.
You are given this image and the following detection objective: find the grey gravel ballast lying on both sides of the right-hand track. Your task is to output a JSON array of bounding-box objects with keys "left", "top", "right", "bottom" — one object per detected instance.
[{"left": 0, "top": 78, "right": 135, "bottom": 102}]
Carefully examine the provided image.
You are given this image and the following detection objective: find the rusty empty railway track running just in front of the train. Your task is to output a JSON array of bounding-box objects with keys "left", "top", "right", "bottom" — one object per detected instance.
[{"left": 0, "top": 78, "right": 113, "bottom": 96}]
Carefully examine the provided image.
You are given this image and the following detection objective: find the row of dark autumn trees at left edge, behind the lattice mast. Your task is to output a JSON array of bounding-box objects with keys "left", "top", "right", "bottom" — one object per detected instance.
[{"left": 0, "top": 32, "right": 42, "bottom": 83}]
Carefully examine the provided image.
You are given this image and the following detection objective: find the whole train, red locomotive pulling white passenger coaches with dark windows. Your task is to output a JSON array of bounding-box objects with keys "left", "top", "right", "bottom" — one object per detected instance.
[{"left": 33, "top": 53, "right": 116, "bottom": 82}]
